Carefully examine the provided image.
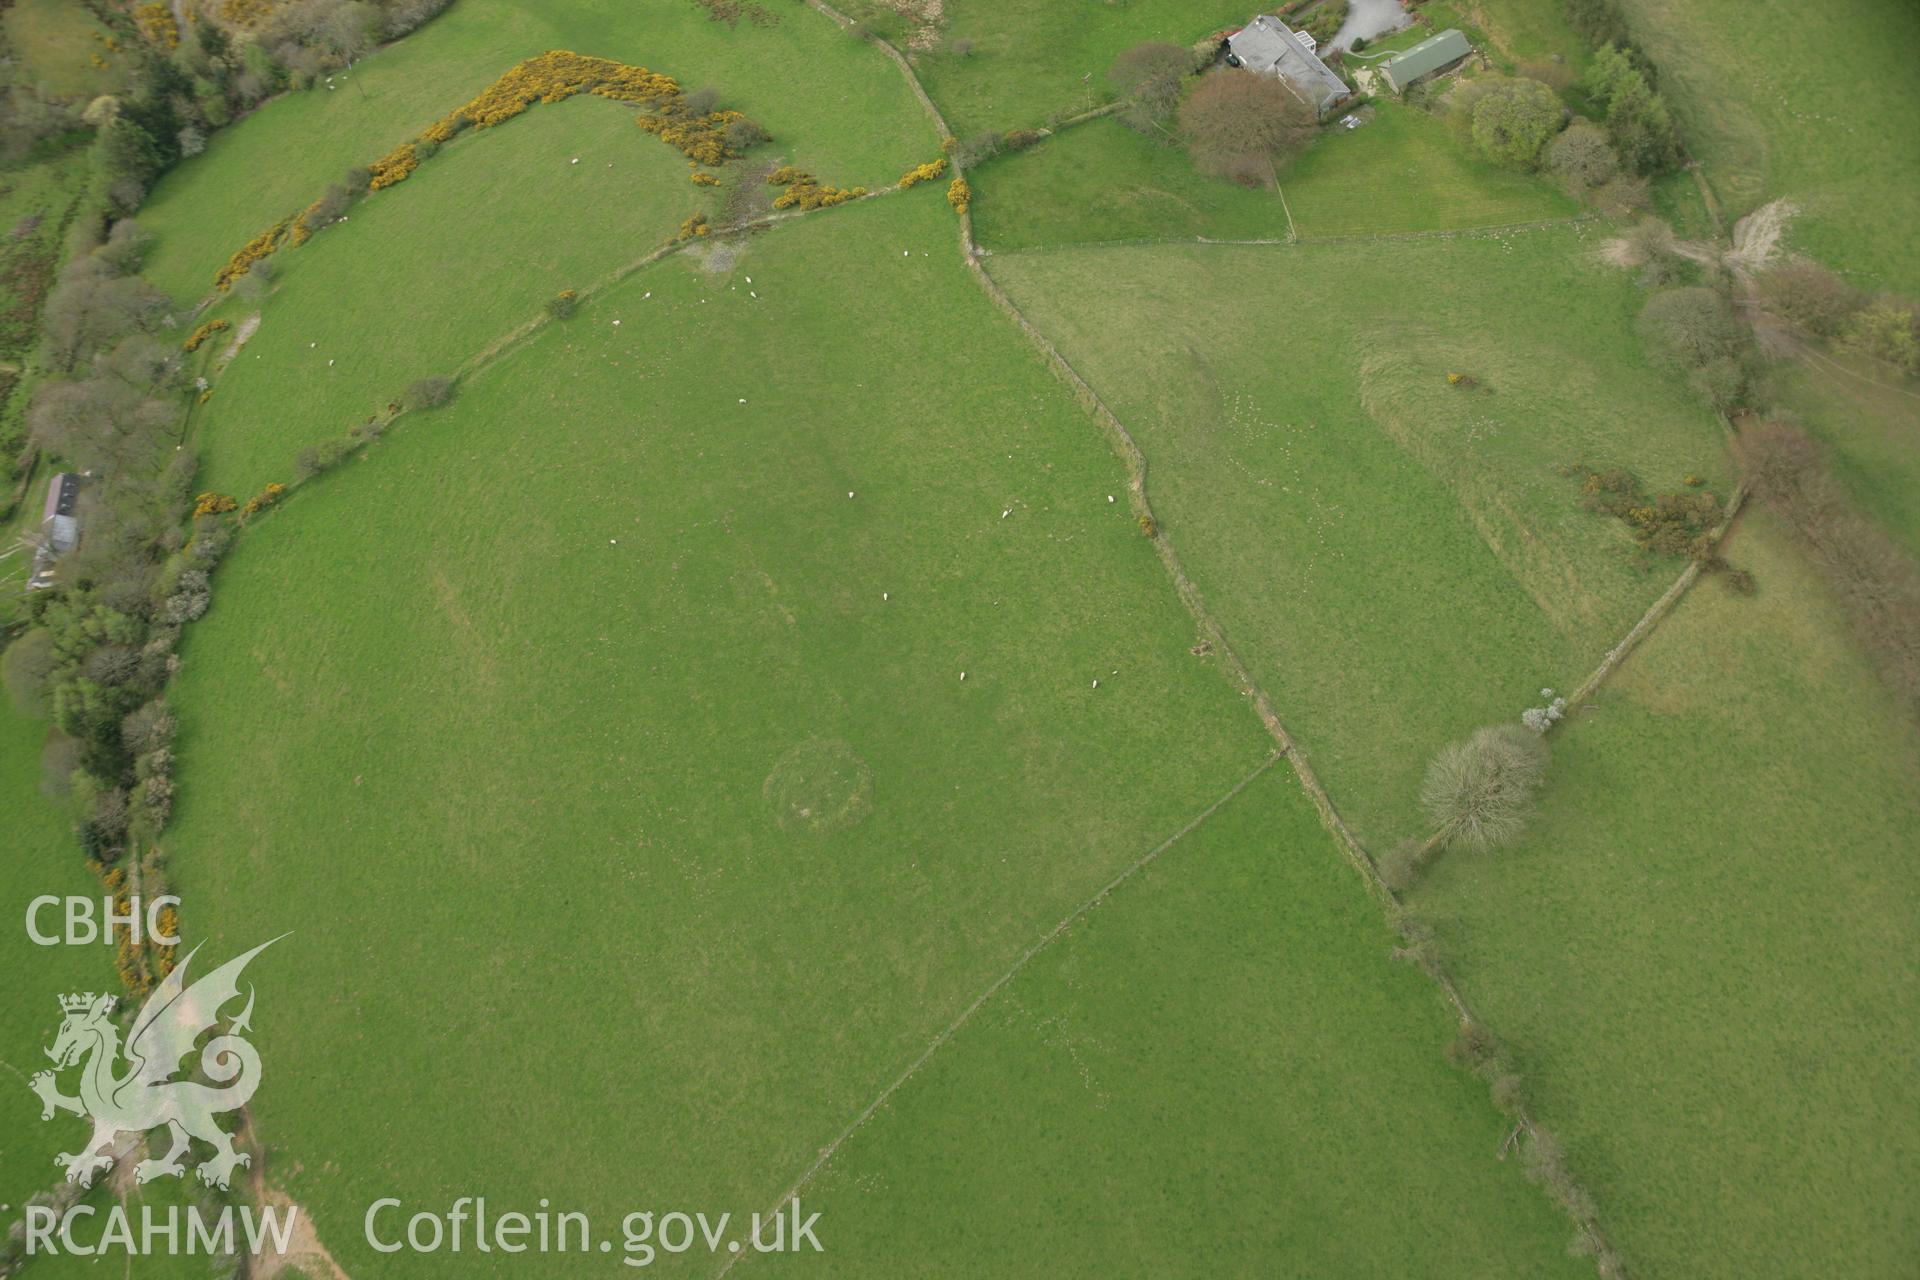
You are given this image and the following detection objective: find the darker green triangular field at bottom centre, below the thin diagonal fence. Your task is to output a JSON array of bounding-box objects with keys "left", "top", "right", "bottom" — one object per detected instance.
[{"left": 755, "top": 766, "right": 1590, "bottom": 1276}]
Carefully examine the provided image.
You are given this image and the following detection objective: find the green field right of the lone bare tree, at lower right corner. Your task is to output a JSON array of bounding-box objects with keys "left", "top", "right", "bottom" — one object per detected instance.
[{"left": 1413, "top": 514, "right": 1920, "bottom": 1276}]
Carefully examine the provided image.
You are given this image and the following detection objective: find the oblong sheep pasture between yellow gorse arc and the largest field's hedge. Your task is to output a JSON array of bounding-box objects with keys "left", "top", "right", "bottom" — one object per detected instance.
[{"left": 190, "top": 98, "right": 712, "bottom": 497}]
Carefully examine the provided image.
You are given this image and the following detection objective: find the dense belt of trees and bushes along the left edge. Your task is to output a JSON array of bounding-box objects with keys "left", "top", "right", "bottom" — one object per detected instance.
[{"left": 0, "top": 0, "right": 464, "bottom": 994}]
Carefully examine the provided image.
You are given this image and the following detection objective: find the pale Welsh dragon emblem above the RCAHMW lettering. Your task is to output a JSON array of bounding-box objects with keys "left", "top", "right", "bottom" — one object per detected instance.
[{"left": 29, "top": 935, "right": 284, "bottom": 1188}]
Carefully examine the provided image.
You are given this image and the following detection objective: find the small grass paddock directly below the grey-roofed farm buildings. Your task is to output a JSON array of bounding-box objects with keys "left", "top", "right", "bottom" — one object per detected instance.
[{"left": 975, "top": 102, "right": 1578, "bottom": 249}]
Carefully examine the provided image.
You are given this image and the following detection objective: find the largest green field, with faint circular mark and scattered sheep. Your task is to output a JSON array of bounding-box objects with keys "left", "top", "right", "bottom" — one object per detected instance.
[{"left": 149, "top": 192, "right": 1559, "bottom": 1270}]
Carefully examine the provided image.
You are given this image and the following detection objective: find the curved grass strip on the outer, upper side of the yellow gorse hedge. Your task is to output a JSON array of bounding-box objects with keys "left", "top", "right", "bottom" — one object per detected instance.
[{"left": 140, "top": 0, "right": 939, "bottom": 299}]
